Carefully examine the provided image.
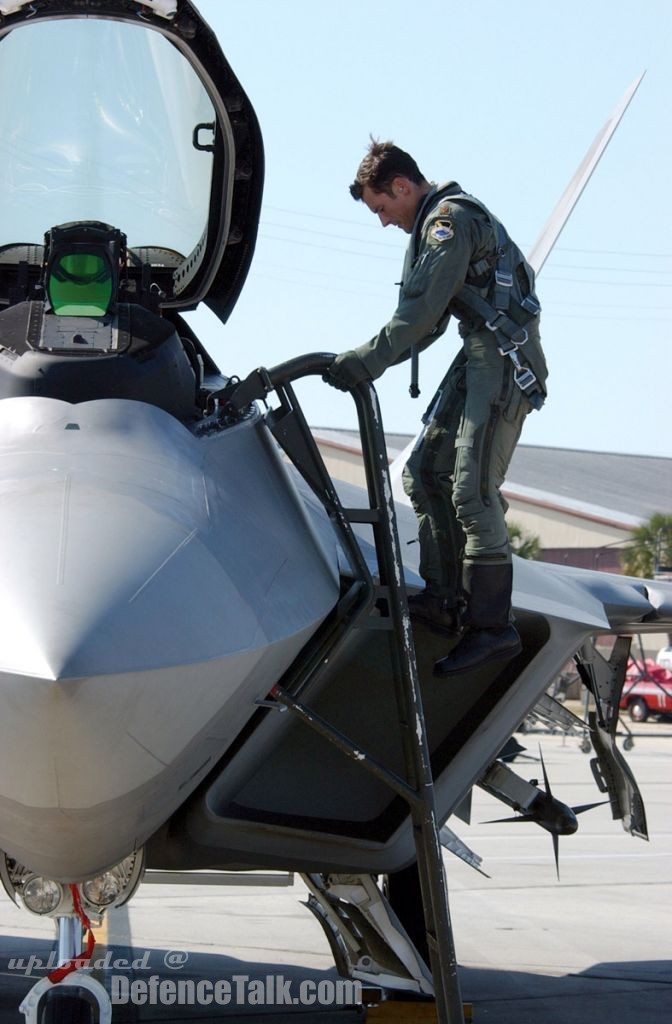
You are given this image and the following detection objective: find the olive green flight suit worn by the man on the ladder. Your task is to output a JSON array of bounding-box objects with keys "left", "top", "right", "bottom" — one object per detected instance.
[{"left": 351, "top": 183, "right": 547, "bottom": 626}]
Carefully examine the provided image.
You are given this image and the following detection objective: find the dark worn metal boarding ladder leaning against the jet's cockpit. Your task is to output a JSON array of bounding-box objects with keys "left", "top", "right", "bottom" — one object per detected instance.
[{"left": 219, "top": 353, "right": 464, "bottom": 1024}]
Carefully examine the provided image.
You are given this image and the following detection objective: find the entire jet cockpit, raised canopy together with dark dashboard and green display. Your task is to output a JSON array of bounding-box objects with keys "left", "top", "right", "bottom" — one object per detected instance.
[{"left": 0, "top": 0, "right": 263, "bottom": 420}]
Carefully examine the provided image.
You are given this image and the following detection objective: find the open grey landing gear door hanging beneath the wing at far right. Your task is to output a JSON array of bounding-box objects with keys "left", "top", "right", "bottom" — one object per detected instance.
[{"left": 576, "top": 637, "right": 648, "bottom": 840}]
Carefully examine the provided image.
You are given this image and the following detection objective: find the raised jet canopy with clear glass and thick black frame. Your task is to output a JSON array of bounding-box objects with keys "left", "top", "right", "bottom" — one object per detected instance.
[{"left": 0, "top": 0, "right": 263, "bottom": 319}]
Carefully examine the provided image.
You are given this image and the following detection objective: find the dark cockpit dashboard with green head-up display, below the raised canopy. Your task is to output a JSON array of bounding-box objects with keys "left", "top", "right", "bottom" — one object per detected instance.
[{"left": 0, "top": 221, "right": 206, "bottom": 421}]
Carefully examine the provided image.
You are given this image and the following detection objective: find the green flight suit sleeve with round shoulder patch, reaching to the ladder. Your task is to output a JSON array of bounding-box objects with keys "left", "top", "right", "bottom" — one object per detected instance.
[{"left": 354, "top": 206, "right": 477, "bottom": 380}]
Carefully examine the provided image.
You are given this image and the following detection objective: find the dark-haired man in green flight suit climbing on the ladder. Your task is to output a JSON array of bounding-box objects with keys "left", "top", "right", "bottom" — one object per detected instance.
[{"left": 325, "top": 139, "right": 547, "bottom": 677}]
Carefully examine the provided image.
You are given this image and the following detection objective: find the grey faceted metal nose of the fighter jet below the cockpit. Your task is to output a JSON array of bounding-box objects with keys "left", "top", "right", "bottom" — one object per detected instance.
[{"left": 0, "top": 399, "right": 338, "bottom": 880}]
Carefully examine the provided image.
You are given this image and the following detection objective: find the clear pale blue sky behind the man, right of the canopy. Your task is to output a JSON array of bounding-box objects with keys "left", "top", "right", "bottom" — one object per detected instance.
[{"left": 185, "top": 0, "right": 672, "bottom": 456}]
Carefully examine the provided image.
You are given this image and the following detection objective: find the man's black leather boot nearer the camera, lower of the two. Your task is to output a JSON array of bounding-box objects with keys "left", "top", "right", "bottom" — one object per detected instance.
[{"left": 434, "top": 562, "right": 522, "bottom": 678}]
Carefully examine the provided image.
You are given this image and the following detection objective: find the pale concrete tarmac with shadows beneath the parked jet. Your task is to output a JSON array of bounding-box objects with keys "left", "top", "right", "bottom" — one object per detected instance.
[{"left": 0, "top": 722, "right": 672, "bottom": 1024}]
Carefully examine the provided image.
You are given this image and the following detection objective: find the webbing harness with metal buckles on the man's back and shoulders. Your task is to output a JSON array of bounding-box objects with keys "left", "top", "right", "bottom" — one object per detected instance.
[{"left": 411, "top": 182, "right": 546, "bottom": 409}]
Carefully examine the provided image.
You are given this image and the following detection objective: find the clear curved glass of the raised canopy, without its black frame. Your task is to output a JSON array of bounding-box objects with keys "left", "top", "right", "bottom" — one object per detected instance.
[{"left": 0, "top": 18, "right": 215, "bottom": 256}]
